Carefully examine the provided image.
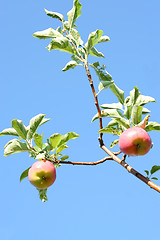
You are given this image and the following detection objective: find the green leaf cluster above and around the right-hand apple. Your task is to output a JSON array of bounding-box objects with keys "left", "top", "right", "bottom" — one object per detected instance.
[{"left": 92, "top": 83, "right": 160, "bottom": 147}]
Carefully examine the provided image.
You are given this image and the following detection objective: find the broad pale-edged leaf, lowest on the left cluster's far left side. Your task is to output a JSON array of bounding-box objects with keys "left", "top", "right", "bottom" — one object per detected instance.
[{"left": 4, "top": 139, "right": 29, "bottom": 156}]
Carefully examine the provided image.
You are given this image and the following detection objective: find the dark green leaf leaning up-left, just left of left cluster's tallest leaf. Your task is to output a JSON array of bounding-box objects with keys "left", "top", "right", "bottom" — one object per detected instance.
[{"left": 12, "top": 119, "right": 27, "bottom": 140}]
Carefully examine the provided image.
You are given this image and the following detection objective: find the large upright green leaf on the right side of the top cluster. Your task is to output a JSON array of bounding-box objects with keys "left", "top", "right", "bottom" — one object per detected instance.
[{"left": 85, "top": 29, "right": 103, "bottom": 53}]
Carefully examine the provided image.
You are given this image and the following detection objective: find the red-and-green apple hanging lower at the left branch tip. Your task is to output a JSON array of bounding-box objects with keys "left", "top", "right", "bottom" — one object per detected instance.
[{"left": 28, "top": 160, "right": 56, "bottom": 189}]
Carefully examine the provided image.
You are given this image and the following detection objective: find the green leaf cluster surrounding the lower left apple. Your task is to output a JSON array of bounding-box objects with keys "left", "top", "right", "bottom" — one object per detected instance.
[{"left": 0, "top": 114, "right": 79, "bottom": 200}]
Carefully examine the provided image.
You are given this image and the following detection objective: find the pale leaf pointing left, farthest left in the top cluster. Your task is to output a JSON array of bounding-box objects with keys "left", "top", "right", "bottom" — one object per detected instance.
[{"left": 33, "top": 28, "right": 63, "bottom": 39}]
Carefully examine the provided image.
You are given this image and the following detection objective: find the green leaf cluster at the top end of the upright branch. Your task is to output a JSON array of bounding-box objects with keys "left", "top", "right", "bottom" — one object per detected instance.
[{"left": 33, "top": 0, "right": 110, "bottom": 71}]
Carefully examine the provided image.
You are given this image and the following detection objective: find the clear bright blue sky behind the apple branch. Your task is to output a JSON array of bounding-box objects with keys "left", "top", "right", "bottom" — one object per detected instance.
[{"left": 0, "top": 0, "right": 160, "bottom": 240}]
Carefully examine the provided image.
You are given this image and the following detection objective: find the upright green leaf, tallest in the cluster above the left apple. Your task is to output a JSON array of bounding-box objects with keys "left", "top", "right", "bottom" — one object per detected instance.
[{"left": 27, "top": 114, "right": 46, "bottom": 139}]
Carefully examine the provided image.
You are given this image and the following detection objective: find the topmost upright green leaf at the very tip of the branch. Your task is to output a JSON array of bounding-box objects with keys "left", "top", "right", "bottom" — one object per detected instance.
[{"left": 67, "top": 0, "right": 82, "bottom": 29}]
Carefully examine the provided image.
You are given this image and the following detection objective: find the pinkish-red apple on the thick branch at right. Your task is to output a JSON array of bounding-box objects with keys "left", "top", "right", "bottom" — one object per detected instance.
[{"left": 119, "top": 127, "right": 152, "bottom": 156}]
